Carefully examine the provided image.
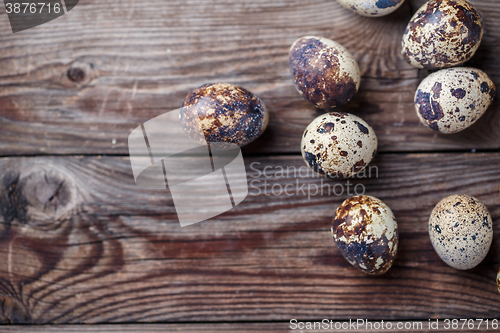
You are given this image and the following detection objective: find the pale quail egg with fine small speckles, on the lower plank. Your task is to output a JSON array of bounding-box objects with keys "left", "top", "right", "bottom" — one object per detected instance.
[{"left": 429, "top": 195, "right": 493, "bottom": 270}]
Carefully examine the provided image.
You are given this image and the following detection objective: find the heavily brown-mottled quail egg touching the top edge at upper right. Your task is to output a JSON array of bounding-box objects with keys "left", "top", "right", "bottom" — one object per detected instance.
[{"left": 401, "top": 0, "right": 483, "bottom": 69}]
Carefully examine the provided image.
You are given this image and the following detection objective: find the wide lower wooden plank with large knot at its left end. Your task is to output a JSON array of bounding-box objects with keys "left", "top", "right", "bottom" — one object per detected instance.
[{"left": 0, "top": 153, "right": 500, "bottom": 324}]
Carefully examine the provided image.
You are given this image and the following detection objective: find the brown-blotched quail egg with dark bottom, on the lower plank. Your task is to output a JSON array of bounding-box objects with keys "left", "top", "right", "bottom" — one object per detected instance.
[{"left": 332, "top": 195, "right": 399, "bottom": 275}]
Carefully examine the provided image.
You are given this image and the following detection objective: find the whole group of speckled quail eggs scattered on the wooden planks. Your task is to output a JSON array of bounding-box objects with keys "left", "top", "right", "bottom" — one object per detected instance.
[{"left": 181, "top": 0, "right": 500, "bottom": 291}]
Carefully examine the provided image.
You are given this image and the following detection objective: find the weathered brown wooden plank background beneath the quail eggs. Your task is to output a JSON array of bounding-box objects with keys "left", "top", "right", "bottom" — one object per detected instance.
[{"left": 0, "top": 0, "right": 500, "bottom": 332}]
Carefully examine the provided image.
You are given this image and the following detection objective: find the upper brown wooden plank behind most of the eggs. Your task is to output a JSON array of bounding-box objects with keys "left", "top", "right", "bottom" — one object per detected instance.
[{"left": 0, "top": 0, "right": 500, "bottom": 156}]
